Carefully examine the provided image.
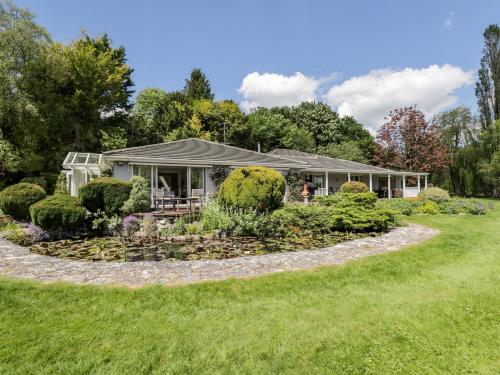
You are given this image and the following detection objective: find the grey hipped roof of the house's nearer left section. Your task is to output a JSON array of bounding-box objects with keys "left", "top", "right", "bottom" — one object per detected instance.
[{"left": 104, "top": 138, "right": 308, "bottom": 169}]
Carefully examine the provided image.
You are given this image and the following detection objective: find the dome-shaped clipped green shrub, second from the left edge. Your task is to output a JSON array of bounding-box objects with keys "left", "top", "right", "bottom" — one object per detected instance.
[{"left": 30, "top": 195, "right": 86, "bottom": 230}]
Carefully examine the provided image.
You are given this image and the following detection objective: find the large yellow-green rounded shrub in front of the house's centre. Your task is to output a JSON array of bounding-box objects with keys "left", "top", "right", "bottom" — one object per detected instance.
[{"left": 219, "top": 167, "right": 285, "bottom": 212}]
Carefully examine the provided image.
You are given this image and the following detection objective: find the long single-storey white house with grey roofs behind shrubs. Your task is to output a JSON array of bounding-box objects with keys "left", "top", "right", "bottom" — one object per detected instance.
[{"left": 63, "top": 138, "right": 427, "bottom": 200}]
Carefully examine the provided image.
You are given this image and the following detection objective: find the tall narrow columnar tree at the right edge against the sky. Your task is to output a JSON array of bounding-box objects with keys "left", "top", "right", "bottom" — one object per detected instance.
[{"left": 476, "top": 25, "right": 500, "bottom": 129}]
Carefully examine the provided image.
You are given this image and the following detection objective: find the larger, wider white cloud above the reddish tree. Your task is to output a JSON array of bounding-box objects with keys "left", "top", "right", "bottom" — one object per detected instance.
[{"left": 324, "top": 64, "right": 474, "bottom": 132}]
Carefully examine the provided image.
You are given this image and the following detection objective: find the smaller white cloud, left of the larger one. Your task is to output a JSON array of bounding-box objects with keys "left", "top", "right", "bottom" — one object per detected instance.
[{"left": 238, "top": 72, "right": 323, "bottom": 112}]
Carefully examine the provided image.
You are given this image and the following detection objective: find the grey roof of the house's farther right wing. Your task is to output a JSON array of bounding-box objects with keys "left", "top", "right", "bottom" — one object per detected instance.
[{"left": 269, "top": 149, "right": 398, "bottom": 173}]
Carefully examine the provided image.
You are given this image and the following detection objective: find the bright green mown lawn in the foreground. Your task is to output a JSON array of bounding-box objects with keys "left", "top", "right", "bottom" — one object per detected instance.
[{"left": 0, "top": 202, "right": 500, "bottom": 374}]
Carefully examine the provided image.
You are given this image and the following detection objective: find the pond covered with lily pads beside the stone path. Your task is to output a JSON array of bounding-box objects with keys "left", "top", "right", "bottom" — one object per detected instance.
[{"left": 30, "top": 232, "right": 377, "bottom": 262}]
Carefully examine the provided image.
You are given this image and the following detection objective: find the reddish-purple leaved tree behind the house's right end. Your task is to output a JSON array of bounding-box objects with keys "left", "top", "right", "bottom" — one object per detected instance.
[{"left": 374, "top": 107, "right": 449, "bottom": 172}]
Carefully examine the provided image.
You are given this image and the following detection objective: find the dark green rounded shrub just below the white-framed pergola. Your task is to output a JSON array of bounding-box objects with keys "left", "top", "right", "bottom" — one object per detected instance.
[{"left": 78, "top": 177, "right": 132, "bottom": 215}]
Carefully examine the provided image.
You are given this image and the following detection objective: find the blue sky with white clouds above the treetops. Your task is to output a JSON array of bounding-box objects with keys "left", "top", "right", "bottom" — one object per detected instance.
[{"left": 16, "top": 0, "right": 500, "bottom": 132}]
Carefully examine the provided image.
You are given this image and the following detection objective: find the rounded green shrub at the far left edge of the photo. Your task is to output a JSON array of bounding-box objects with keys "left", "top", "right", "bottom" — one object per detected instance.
[{"left": 0, "top": 182, "right": 47, "bottom": 220}]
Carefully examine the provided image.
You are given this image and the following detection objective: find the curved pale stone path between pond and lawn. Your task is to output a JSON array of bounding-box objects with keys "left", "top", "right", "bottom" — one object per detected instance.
[{"left": 0, "top": 224, "right": 439, "bottom": 287}]
